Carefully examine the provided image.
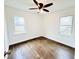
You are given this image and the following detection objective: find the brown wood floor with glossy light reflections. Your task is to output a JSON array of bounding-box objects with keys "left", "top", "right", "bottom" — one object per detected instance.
[{"left": 8, "top": 37, "right": 74, "bottom": 59}]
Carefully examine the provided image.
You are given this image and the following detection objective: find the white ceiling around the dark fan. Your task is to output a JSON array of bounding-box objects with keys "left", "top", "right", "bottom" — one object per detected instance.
[{"left": 5, "top": 0, "right": 75, "bottom": 11}]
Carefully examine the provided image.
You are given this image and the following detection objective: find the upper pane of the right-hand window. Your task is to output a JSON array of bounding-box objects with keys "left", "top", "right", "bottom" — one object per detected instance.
[{"left": 60, "top": 16, "right": 73, "bottom": 25}]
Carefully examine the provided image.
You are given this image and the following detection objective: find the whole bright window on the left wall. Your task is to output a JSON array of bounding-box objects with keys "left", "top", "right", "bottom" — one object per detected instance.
[{"left": 14, "top": 16, "right": 25, "bottom": 34}]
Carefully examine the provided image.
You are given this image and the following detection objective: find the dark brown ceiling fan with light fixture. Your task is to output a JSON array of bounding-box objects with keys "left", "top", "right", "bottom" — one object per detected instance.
[{"left": 29, "top": 0, "right": 53, "bottom": 12}]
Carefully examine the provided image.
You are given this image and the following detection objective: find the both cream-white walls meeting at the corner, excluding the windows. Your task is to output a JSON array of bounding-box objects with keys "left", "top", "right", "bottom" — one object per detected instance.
[{"left": 5, "top": 6, "right": 75, "bottom": 47}]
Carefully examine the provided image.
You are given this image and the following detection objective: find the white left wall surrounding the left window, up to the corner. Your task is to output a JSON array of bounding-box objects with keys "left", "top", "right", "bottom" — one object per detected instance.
[{"left": 5, "top": 6, "right": 42, "bottom": 44}]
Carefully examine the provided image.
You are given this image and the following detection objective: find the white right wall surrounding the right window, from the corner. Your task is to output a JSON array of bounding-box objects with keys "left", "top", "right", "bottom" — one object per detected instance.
[{"left": 44, "top": 7, "right": 75, "bottom": 47}]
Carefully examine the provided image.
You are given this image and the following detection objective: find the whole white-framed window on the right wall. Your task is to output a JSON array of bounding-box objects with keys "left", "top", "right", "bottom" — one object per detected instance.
[{"left": 60, "top": 16, "right": 73, "bottom": 35}]
